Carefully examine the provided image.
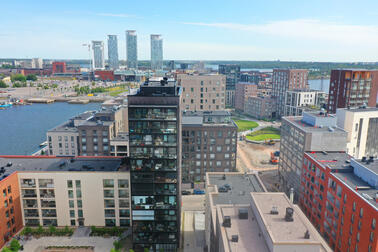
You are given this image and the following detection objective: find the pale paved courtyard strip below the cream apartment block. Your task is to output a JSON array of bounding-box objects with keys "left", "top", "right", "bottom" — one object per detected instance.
[{"left": 22, "top": 236, "right": 117, "bottom": 252}]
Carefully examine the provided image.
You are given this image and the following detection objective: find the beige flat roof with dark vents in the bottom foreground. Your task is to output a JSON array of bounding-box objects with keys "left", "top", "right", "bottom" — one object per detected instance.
[{"left": 216, "top": 192, "right": 333, "bottom": 252}]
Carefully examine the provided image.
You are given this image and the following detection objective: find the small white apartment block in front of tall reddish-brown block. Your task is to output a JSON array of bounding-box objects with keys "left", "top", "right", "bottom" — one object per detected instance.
[{"left": 284, "top": 89, "right": 325, "bottom": 116}]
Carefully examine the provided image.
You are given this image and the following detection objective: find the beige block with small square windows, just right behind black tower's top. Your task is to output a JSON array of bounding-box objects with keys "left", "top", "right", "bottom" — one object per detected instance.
[{"left": 177, "top": 74, "right": 226, "bottom": 111}]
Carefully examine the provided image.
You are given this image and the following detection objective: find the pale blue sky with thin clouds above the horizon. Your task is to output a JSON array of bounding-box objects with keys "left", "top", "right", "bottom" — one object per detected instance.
[{"left": 0, "top": 0, "right": 378, "bottom": 62}]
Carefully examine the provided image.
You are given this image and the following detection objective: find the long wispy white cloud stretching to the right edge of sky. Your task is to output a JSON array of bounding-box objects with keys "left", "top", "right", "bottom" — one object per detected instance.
[{"left": 183, "top": 19, "right": 378, "bottom": 48}]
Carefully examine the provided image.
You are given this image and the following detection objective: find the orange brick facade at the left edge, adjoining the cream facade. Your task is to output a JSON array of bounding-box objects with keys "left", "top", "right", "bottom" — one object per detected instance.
[{"left": 0, "top": 172, "right": 23, "bottom": 248}]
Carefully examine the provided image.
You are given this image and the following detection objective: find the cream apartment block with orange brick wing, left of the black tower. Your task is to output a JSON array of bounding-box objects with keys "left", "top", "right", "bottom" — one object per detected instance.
[{"left": 0, "top": 156, "right": 131, "bottom": 244}]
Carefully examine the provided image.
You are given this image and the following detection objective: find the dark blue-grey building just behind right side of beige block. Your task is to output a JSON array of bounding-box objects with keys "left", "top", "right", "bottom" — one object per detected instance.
[{"left": 218, "top": 64, "right": 240, "bottom": 107}]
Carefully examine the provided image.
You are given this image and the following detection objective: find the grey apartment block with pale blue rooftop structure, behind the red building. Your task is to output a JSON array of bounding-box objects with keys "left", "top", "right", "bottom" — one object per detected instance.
[{"left": 278, "top": 112, "right": 347, "bottom": 202}]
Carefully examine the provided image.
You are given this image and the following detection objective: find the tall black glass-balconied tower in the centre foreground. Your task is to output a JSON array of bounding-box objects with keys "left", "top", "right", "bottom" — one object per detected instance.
[{"left": 128, "top": 78, "right": 181, "bottom": 252}]
